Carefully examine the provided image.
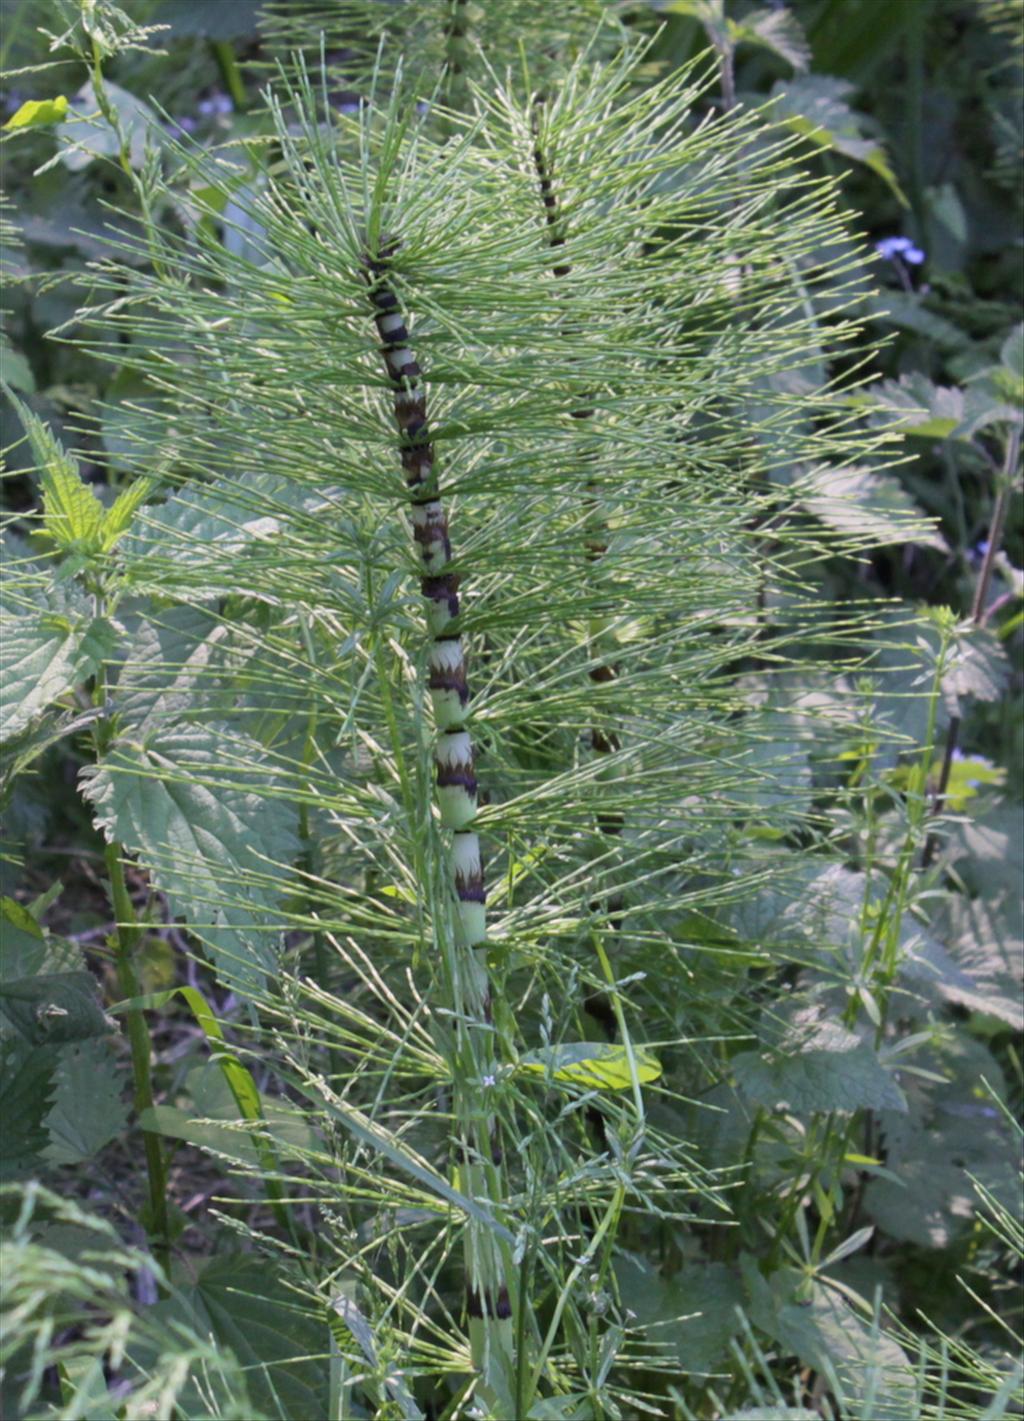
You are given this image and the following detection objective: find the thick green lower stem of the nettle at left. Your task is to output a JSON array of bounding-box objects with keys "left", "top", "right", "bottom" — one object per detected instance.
[{"left": 104, "top": 844, "right": 170, "bottom": 1279}]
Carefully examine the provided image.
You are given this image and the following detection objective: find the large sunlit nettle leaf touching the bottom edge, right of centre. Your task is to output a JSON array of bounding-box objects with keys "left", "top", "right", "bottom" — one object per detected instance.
[{"left": 740, "top": 1253, "right": 919, "bottom": 1421}]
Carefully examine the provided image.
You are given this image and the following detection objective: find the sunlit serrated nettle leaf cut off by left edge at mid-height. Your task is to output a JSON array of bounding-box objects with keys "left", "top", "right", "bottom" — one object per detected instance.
[{"left": 0, "top": 598, "right": 116, "bottom": 737}]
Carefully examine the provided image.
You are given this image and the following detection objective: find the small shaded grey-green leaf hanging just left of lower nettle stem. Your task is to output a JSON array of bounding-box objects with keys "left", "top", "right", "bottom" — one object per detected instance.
[{"left": 45, "top": 1040, "right": 128, "bottom": 1164}]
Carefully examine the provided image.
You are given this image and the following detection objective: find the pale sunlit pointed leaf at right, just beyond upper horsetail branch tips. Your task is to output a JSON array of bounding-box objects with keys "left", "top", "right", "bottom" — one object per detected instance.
[{"left": 797, "top": 466, "right": 946, "bottom": 550}]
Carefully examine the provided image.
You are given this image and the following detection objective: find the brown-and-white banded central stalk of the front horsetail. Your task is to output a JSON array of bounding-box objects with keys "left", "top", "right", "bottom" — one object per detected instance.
[{"left": 364, "top": 243, "right": 514, "bottom": 1421}]
